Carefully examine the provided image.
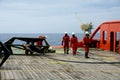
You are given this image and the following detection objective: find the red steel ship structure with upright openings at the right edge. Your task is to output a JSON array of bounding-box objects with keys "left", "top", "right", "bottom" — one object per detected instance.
[{"left": 78, "top": 20, "right": 120, "bottom": 53}]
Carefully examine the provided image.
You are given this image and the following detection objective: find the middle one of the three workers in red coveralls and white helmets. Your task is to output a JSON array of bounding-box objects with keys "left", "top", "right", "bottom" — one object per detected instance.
[{"left": 70, "top": 32, "right": 78, "bottom": 55}]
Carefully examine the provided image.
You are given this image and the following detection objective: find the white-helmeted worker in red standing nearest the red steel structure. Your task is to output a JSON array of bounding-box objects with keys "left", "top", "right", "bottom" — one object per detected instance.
[{"left": 83, "top": 31, "right": 90, "bottom": 58}]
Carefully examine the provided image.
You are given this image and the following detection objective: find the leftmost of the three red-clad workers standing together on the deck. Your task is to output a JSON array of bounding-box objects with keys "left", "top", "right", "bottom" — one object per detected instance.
[{"left": 62, "top": 32, "right": 70, "bottom": 54}]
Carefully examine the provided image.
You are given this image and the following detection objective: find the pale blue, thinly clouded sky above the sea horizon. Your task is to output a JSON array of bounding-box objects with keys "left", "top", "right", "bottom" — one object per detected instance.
[{"left": 0, "top": 0, "right": 120, "bottom": 33}]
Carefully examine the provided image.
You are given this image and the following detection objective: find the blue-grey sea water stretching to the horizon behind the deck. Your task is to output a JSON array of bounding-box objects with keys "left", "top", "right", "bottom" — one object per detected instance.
[{"left": 0, "top": 33, "right": 98, "bottom": 46}]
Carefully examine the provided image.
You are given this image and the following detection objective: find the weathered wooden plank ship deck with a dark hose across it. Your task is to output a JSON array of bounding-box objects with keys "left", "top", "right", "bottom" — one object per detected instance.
[{"left": 0, "top": 49, "right": 120, "bottom": 80}]
